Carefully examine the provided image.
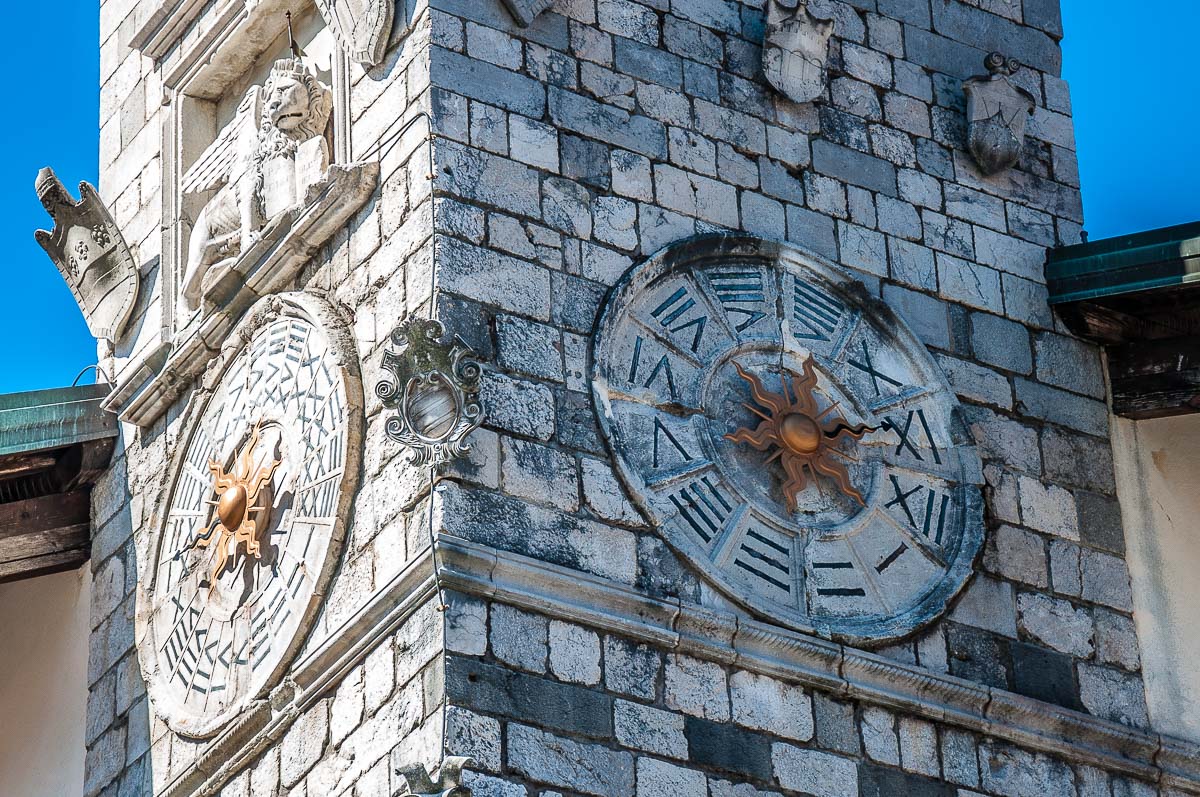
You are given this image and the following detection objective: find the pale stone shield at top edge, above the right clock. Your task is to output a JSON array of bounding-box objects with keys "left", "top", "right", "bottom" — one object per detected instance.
[{"left": 762, "top": 0, "right": 833, "bottom": 102}]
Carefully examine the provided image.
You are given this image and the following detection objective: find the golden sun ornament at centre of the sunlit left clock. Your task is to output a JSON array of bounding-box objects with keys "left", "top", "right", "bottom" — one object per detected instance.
[{"left": 181, "top": 423, "right": 281, "bottom": 593}]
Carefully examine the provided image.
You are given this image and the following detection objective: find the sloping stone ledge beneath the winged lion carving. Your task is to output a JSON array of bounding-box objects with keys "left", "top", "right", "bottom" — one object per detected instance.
[{"left": 103, "top": 162, "right": 379, "bottom": 427}]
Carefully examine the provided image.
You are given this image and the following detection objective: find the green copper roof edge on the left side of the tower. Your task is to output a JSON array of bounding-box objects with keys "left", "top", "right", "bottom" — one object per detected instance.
[{"left": 0, "top": 385, "right": 118, "bottom": 456}]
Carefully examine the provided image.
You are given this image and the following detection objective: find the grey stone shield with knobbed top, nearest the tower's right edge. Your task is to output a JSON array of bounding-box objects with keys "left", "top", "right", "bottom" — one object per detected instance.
[{"left": 962, "top": 53, "right": 1037, "bottom": 174}]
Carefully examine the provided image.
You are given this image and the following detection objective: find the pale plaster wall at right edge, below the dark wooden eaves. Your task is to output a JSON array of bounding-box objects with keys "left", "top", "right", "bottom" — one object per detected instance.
[{"left": 1112, "top": 415, "right": 1200, "bottom": 742}]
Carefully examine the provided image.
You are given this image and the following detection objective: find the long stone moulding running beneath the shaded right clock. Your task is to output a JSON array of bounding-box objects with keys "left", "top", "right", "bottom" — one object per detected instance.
[{"left": 438, "top": 537, "right": 1200, "bottom": 795}]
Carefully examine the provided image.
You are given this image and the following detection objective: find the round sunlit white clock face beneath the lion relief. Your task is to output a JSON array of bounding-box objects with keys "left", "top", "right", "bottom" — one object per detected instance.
[{"left": 139, "top": 295, "right": 361, "bottom": 736}]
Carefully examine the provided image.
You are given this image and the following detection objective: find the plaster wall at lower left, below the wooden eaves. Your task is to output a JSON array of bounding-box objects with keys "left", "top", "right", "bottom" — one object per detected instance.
[{"left": 0, "top": 567, "right": 91, "bottom": 797}]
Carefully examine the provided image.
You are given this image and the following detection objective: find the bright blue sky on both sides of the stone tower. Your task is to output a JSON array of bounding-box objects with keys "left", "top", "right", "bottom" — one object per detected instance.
[{"left": 0, "top": 0, "right": 1200, "bottom": 392}]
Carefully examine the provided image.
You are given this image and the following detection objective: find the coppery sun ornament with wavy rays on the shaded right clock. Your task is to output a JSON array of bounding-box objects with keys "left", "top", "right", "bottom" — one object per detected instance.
[{"left": 725, "top": 356, "right": 875, "bottom": 513}]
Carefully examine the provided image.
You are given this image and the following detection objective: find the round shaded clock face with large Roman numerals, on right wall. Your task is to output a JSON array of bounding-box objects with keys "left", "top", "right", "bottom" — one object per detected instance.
[{"left": 593, "top": 235, "right": 983, "bottom": 643}]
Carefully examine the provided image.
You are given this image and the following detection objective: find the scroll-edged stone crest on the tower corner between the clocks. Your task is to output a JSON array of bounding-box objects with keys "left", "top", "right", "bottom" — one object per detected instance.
[{"left": 376, "top": 319, "right": 484, "bottom": 466}]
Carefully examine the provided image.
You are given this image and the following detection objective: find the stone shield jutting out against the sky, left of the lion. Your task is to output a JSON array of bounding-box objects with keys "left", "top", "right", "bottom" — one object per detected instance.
[{"left": 34, "top": 167, "right": 140, "bottom": 342}]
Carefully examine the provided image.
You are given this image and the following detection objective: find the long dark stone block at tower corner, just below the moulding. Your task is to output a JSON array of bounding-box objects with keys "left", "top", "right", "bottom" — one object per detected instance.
[{"left": 445, "top": 655, "right": 613, "bottom": 739}]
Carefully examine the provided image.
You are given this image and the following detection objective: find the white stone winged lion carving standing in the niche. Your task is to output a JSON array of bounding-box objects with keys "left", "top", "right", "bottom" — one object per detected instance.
[{"left": 181, "top": 58, "right": 334, "bottom": 316}]
